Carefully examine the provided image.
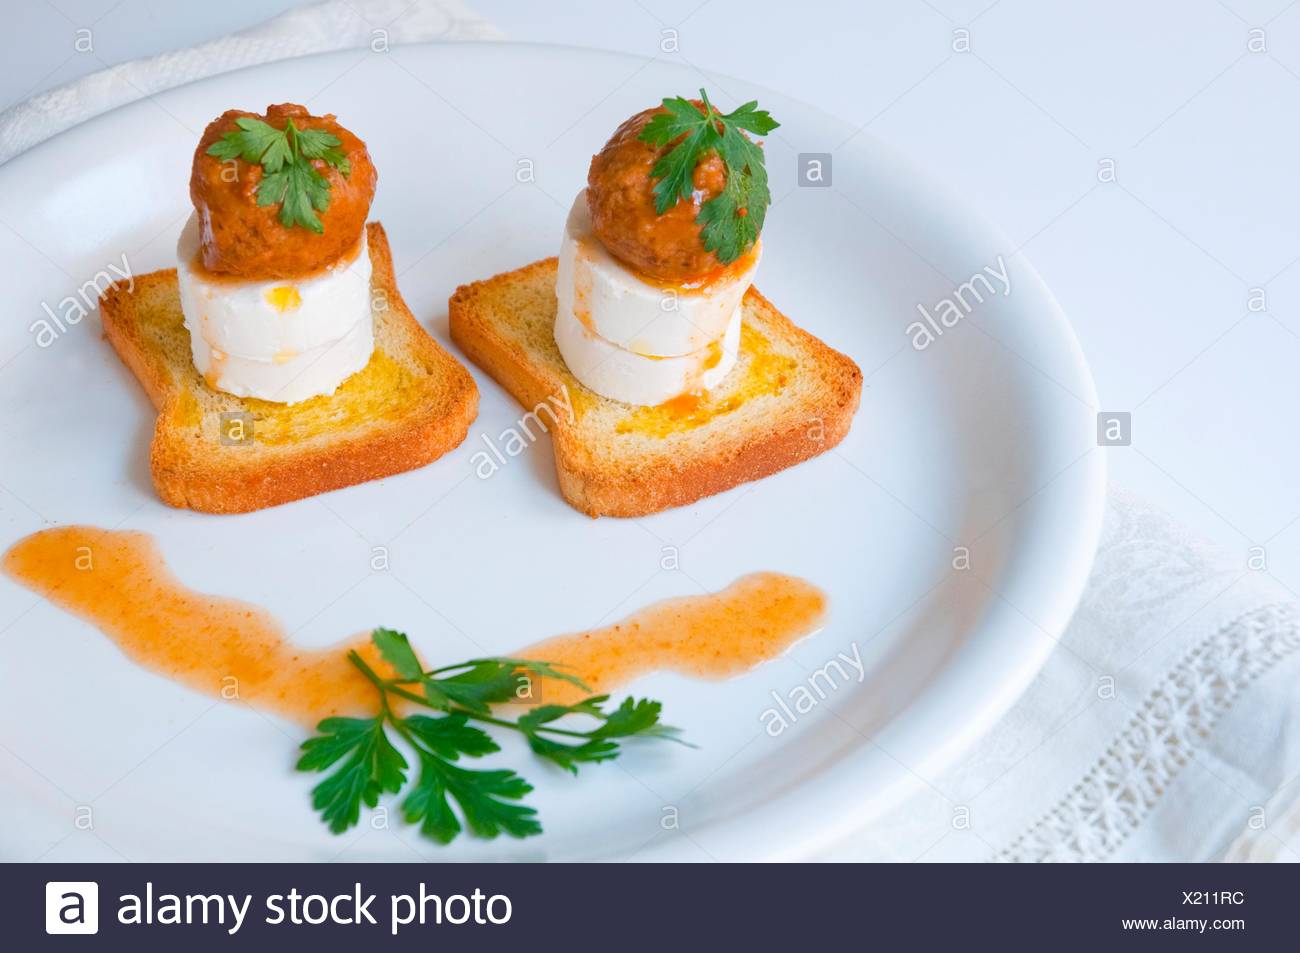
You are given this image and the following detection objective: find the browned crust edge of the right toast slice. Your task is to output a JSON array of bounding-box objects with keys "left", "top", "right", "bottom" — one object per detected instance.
[{"left": 449, "top": 257, "right": 862, "bottom": 516}]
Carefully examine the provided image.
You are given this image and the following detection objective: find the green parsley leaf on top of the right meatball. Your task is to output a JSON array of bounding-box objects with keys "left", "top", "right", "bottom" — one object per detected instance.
[{"left": 638, "top": 90, "right": 781, "bottom": 265}]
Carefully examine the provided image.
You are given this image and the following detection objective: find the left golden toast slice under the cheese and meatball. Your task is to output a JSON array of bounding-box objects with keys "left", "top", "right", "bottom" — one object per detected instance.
[{"left": 100, "top": 222, "right": 478, "bottom": 514}]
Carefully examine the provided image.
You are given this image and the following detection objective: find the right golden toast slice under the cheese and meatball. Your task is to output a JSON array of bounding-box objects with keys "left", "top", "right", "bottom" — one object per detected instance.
[{"left": 449, "top": 257, "right": 862, "bottom": 516}]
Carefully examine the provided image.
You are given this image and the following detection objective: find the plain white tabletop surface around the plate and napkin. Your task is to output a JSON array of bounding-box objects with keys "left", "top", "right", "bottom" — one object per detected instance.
[{"left": 0, "top": 0, "right": 1300, "bottom": 592}]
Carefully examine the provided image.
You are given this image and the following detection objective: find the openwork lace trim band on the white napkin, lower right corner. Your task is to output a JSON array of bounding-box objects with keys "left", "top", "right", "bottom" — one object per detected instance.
[{"left": 996, "top": 603, "right": 1300, "bottom": 862}]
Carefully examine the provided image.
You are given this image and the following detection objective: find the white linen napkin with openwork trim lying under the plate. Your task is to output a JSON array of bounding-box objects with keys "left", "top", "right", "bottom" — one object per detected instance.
[{"left": 0, "top": 0, "right": 1300, "bottom": 861}]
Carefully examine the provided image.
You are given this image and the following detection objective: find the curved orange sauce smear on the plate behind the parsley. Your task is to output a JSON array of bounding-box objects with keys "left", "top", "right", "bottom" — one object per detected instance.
[{"left": 4, "top": 527, "right": 826, "bottom": 725}]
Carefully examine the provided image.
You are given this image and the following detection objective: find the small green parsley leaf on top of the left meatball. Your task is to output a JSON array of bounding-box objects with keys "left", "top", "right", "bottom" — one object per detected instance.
[{"left": 208, "top": 116, "right": 352, "bottom": 234}]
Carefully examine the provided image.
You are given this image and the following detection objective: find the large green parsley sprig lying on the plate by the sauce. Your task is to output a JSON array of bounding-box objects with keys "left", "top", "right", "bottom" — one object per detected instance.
[{"left": 298, "top": 628, "right": 680, "bottom": 844}]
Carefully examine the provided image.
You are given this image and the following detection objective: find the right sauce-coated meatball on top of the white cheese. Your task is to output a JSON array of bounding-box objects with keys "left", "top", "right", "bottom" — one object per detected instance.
[{"left": 586, "top": 101, "right": 727, "bottom": 282}]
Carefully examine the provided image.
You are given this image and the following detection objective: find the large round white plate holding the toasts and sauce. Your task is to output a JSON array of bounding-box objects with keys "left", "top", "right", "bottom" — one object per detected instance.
[{"left": 0, "top": 44, "right": 1102, "bottom": 859}]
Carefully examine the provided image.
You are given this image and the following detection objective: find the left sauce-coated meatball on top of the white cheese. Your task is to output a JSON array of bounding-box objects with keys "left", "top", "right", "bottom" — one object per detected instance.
[{"left": 190, "top": 103, "right": 377, "bottom": 280}]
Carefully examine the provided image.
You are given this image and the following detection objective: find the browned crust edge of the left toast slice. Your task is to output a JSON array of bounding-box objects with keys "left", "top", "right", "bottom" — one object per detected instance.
[{"left": 101, "top": 222, "right": 478, "bottom": 514}]
